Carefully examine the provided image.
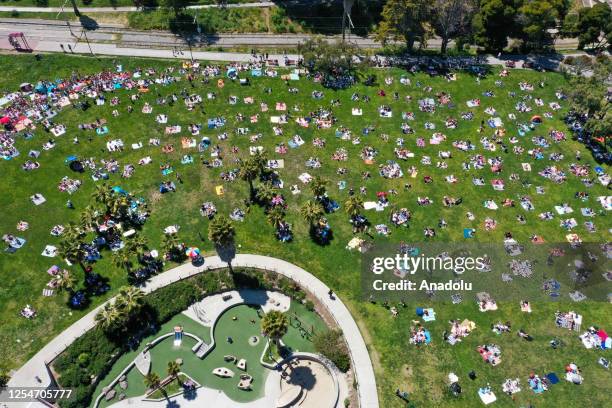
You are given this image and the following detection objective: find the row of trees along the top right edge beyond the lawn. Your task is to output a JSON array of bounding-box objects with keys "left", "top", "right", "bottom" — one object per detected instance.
[{"left": 376, "top": 0, "right": 612, "bottom": 54}]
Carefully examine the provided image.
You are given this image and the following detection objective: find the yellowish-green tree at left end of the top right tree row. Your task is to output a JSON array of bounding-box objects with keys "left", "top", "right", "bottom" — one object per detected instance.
[{"left": 376, "top": 0, "right": 431, "bottom": 51}]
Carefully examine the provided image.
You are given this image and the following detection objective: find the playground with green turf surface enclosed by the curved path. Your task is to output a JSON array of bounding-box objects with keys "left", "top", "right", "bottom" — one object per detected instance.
[{"left": 92, "top": 291, "right": 329, "bottom": 407}]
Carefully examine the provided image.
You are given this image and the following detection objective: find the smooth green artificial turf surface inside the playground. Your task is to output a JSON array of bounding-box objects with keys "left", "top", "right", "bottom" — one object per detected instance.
[{"left": 94, "top": 302, "right": 325, "bottom": 407}]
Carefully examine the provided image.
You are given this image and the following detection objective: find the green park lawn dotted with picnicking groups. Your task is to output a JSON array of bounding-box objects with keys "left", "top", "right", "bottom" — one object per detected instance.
[{"left": 0, "top": 55, "right": 612, "bottom": 407}]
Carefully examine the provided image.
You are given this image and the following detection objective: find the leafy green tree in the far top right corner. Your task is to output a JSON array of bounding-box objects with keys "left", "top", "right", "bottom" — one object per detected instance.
[{"left": 576, "top": 3, "right": 612, "bottom": 51}]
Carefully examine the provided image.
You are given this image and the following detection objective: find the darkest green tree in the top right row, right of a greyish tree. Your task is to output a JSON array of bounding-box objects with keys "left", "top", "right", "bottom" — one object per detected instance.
[{"left": 472, "top": 0, "right": 519, "bottom": 52}]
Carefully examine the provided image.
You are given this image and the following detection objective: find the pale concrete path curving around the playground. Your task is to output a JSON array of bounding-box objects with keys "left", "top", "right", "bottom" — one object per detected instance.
[{"left": 8, "top": 254, "right": 378, "bottom": 408}]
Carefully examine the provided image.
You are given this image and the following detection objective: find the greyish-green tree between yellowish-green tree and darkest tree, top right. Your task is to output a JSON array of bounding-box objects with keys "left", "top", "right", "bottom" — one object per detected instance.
[{"left": 431, "top": 0, "right": 476, "bottom": 54}]
